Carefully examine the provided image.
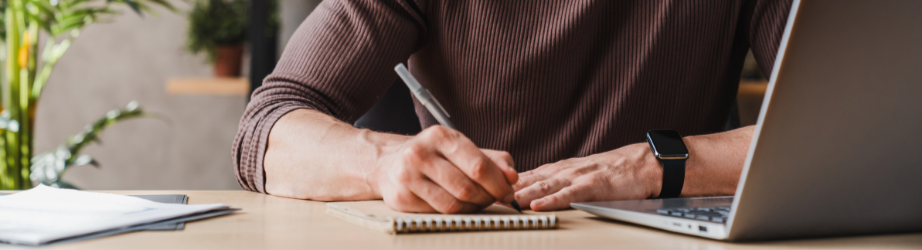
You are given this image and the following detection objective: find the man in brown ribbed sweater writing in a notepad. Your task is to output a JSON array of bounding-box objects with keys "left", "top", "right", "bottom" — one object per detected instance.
[{"left": 234, "top": 0, "right": 790, "bottom": 213}]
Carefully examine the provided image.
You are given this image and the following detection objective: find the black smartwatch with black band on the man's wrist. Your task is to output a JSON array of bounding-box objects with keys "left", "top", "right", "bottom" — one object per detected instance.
[{"left": 647, "top": 130, "right": 688, "bottom": 198}]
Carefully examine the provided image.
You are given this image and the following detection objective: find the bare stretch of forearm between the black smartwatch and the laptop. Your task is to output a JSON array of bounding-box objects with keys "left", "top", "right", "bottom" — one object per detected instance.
[{"left": 672, "top": 126, "right": 754, "bottom": 197}]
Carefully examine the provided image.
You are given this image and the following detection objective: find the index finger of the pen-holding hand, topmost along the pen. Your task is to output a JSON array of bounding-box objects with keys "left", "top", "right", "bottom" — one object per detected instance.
[{"left": 417, "top": 125, "right": 513, "bottom": 203}]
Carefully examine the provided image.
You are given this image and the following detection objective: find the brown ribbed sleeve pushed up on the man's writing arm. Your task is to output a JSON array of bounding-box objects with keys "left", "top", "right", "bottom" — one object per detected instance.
[{"left": 232, "top": 0, "right": 426, "bottom": 193}]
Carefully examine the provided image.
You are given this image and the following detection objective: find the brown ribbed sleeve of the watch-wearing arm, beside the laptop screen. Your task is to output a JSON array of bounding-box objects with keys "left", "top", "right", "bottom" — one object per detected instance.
[{"left": 749, "top": 0, "right": 792, "bottom": 77}]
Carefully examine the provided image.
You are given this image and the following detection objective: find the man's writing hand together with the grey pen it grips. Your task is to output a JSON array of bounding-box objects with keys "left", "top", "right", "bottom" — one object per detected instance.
[{"left": 382, "top": 63, "right": 521, "bottom": 213}]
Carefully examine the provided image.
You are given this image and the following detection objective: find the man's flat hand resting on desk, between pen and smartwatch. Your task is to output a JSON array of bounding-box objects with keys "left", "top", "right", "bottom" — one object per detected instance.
[{"left": 513, "top": 143, "right": 662, "bottom": 211}]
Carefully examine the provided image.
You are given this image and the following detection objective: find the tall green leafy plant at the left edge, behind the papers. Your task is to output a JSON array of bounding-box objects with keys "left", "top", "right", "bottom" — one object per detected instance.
[{"left": 0, "top": 0, "right": 174, "bottom": 189}]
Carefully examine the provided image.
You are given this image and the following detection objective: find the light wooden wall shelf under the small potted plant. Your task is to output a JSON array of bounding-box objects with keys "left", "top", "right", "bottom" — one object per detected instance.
[{"left": 166, "top": 77, "right": 250, "bottom": 96}]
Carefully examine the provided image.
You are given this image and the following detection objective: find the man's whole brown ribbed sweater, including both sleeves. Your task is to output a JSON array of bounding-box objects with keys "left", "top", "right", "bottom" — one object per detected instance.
[{"left": 233, "top": 0, "right": 790, "bottom": 192}]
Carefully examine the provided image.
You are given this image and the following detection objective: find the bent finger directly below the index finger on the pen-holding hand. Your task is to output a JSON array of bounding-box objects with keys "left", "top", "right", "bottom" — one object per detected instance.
[{"left": 421, "top": 157, "right": 496, "bottom": 206}]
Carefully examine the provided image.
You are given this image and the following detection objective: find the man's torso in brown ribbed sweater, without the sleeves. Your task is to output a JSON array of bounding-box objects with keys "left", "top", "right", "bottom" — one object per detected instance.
[{"left": 409, "top": 0, "right": 749, "bottom": 171}]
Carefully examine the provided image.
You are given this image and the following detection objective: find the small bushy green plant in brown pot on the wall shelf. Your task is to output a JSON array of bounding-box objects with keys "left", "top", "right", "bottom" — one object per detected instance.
[{"left": 186, "top": 0, "right": 248, "bottom": 77}]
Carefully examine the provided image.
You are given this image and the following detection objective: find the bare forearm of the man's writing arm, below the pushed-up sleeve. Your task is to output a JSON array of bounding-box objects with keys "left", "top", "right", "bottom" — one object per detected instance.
[{"left": 263, "top": 109, "right": 410, "bottom": 200}]
